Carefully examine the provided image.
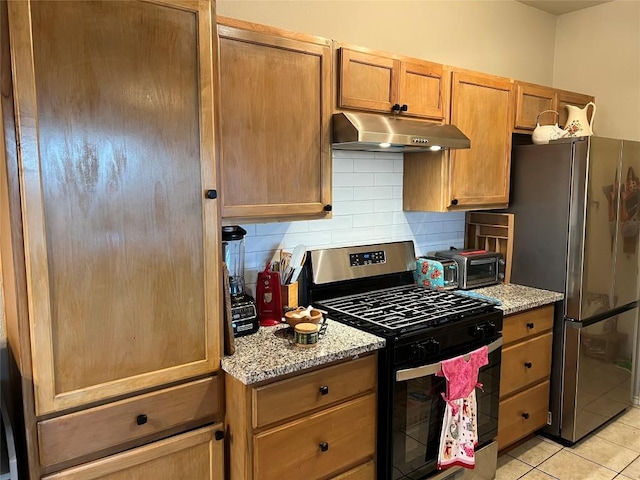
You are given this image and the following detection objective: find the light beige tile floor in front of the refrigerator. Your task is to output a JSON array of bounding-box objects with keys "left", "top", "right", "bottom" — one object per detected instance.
[{"left": 496, "top": 407, "right": 640, "bottom": 480}]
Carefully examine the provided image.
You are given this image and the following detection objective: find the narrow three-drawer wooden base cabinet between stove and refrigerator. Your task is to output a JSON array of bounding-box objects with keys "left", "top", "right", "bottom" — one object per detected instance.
[{"left": 497, "top": 305, "right": 553, "bottom": 450}]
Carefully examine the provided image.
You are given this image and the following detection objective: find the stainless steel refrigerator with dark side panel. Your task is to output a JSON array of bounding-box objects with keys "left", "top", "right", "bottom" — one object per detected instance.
[{"left": 507, "top": 137, "right": 640, "bottom": 444}]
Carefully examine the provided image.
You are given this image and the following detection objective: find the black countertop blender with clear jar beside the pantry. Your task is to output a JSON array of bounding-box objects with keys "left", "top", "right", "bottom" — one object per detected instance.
[{"left": 222, "top": 225, "right": 260, "bottom": 337}]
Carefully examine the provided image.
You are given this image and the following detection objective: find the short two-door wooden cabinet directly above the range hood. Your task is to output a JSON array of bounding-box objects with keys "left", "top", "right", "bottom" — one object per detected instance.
[{"left": 338, "top": 46, "right": 448, "bottom": 121}]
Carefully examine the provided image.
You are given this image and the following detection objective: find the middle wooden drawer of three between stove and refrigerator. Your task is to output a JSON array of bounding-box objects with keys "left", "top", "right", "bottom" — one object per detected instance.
[{"left": 500, "top": 332, "right": 552, "bottom": 398}]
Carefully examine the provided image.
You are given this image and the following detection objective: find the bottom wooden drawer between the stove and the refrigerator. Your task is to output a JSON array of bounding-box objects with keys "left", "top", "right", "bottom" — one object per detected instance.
[{"left": 498, "top": 380, "right": 549, "bottom": 449}]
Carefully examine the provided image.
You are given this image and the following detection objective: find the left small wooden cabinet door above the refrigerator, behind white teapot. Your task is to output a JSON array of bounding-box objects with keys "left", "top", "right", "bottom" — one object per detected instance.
[{"left": 514, "top": 82, "right": 558, "bottom": 133}]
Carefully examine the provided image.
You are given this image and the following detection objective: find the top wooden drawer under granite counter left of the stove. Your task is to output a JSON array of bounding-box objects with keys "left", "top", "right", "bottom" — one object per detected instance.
[{"left": 252, "top": 355, "right": 377, "bottom": 428}]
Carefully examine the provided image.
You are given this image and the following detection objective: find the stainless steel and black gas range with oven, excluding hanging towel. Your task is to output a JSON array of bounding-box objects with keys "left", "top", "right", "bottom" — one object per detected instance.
[{"left": 301, "top": 241, "right": 502, "bottom": 480}]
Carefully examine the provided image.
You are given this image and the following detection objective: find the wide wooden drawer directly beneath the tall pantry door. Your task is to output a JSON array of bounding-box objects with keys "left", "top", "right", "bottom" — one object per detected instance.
[{"left": 38, "top": 377, "right": 220, "bottom": 466}]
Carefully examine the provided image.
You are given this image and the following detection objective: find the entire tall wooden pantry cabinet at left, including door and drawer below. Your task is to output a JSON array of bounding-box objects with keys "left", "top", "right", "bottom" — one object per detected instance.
[{"left": 0, "top": 0, "right": 223, "bottom": 479}]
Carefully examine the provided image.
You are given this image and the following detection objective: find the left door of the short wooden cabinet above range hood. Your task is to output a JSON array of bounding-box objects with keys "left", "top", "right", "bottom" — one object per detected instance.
[{"left": 338, "top": 47, "right": 400, "bottom": 113}]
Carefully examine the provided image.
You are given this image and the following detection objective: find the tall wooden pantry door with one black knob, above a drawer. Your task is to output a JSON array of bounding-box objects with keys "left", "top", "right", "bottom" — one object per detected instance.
[{"left": 9, "top": 0, "right": 220, "bottom": 415}]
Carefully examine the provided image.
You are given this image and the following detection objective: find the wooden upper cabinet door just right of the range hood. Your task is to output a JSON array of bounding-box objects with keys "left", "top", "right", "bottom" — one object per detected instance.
[{"left": 449, "top": 71, "right": 513, "bottom": 209}]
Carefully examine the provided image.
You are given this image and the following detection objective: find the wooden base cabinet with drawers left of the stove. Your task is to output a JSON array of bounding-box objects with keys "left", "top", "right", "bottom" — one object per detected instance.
[{"left": 225, "top": 354, "right": 377, "bottom": 480}]
